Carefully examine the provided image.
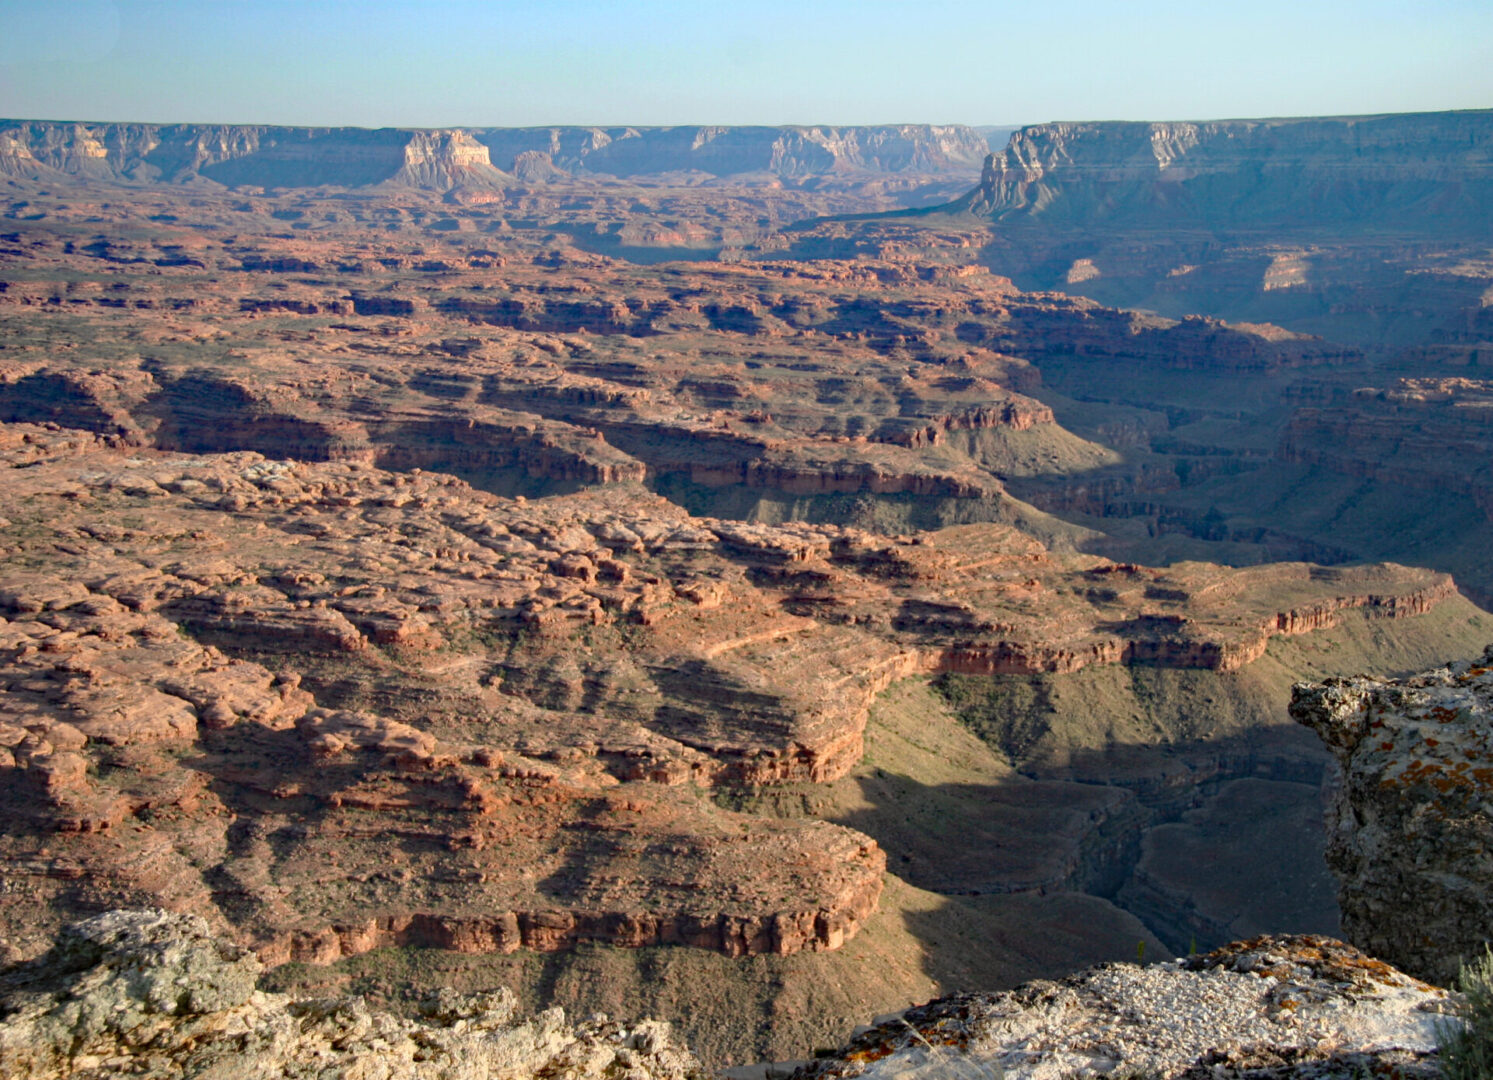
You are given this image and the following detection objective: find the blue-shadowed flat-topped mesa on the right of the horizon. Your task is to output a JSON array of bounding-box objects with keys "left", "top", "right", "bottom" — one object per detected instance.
[{"left": 956, "top": 111, "right": 1493, "bottom": 233}]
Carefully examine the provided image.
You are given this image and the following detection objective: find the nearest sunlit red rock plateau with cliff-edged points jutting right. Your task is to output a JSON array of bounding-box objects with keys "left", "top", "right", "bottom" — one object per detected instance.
[{"left": 0, "top": 426, "right": 1451, "bottom": 962}]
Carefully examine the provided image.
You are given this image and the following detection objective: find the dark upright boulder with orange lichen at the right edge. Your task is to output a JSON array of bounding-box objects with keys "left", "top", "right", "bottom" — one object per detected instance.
[{"left": 1291, "top": 648, "right": 1493, "bottom": 981}]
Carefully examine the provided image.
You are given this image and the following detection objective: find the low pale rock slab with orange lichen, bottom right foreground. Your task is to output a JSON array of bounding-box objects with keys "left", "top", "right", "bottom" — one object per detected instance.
[{"left": 796, "top": 937, "right": 1448, "bottom": 1080}]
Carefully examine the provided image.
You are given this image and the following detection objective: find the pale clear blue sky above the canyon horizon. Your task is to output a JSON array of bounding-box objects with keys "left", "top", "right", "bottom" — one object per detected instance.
[{"left": 0, "top": 0, "right": 1493, "bottom": 127}]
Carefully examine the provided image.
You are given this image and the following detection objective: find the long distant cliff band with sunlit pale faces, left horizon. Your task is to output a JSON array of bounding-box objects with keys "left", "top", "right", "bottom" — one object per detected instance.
[{"left": 0, "top": 120, "right": 985, "bottom": 191}]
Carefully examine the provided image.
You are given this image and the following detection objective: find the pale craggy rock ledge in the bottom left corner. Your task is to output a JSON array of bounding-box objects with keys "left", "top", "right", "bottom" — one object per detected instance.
[{"left": 0, "top": 910, "right": 705, "bottom": 1080}]
